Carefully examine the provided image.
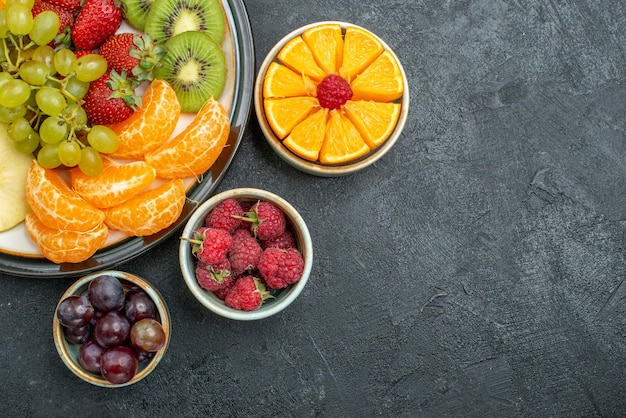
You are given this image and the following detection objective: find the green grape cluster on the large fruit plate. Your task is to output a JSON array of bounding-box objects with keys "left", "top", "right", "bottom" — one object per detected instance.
[{"left": 0, "top": 0, "right": 119, "bottom": 176}]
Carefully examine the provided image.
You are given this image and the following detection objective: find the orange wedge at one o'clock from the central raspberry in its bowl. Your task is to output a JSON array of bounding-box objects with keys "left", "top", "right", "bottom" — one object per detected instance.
[{"left": 339, "top": 26, "right": 385, "bottom": 83}]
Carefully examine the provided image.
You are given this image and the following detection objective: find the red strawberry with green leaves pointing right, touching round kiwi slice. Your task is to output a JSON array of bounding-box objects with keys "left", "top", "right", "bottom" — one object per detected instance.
[{"left": 99, "top": 33, "right": 165, "bottom": 83}]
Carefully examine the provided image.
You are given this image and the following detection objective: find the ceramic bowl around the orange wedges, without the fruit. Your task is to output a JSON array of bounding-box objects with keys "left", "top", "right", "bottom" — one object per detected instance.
[{"left": 254, "top": 21, "right": 409, "bottom": 177}]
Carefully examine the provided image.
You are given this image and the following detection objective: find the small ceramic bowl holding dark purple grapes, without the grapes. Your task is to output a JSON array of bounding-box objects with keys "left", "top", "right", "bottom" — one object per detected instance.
[{"left": 52, "top": 270, "right": 171, "bottom": 388}]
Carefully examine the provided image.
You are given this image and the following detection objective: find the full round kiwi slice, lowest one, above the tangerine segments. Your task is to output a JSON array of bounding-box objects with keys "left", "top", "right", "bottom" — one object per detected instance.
[{"left": 154, "top": 31, "right": 226, "bottom": 112}]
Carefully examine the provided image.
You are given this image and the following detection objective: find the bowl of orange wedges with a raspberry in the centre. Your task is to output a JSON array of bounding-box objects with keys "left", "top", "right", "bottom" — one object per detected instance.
[{"left": 254, "top": 21, "right": 409, "bottom": 177}]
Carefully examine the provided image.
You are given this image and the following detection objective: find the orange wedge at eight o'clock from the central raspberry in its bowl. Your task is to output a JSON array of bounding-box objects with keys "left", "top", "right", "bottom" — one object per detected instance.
[{"left": 263, "top": 96, "right": 319, "bottom": 139}]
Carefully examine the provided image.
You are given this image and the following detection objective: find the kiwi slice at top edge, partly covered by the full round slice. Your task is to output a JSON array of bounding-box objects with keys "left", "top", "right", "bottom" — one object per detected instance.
[{"left": 143, "top": 0, "right": 226, "bottom": 45}]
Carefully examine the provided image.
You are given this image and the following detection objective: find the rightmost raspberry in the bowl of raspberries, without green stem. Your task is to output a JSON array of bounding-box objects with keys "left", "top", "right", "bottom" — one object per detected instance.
[{"left": 258, "top": 247, "right": 304, "bottom": 289}]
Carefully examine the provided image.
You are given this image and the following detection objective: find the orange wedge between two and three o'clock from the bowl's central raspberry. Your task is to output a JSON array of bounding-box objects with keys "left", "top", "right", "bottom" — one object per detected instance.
[{"left": 350, "top": 51, "right": 404, "bottom": 102}]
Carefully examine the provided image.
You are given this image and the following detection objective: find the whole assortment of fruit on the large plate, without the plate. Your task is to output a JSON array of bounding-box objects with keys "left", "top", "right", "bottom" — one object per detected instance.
[{"left": 0, "top": 0, "right": 230, "bottom": 263}]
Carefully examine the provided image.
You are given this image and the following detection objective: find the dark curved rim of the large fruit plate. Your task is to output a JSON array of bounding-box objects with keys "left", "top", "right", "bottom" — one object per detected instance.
[{"left": 0, "top": 0, "right": 255, "bottom": 278}]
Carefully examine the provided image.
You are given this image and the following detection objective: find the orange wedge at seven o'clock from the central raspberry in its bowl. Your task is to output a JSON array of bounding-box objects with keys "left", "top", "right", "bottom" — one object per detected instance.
[{"left": 283, "top": 108, "right": 328, "bottom": 161}]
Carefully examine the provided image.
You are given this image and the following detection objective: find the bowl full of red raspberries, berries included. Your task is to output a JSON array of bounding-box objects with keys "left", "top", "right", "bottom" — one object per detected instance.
[{"left": 179, "top": 188, "right": 313, "bottom": 320}]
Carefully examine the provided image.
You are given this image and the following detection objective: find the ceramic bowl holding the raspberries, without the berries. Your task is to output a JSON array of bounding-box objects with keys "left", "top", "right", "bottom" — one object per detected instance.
[{"left": 179, "top": 188, "right": 313, "bottom": 321}]
